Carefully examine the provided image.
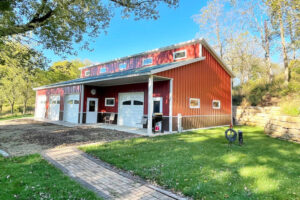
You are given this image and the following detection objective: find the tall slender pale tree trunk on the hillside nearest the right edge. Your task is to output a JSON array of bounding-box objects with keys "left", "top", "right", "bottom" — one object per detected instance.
[{"left": 278, "top": 7, "right": 290, "bottom": 86}]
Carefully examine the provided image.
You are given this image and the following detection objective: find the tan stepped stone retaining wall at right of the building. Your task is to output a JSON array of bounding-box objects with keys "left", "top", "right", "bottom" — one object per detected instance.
[{"left": 232, "top": 106, "right": 300, "bottom": 142}]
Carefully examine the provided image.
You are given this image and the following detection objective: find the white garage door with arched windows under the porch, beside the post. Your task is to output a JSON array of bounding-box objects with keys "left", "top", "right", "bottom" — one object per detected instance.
[{"left": 118, "top": 92, "right": 144, "bottom": 128}]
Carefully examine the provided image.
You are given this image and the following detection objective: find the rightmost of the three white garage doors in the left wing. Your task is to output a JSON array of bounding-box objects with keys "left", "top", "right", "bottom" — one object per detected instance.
[{"left": 64, "top": 94, "right": 79, "bottom": 124}]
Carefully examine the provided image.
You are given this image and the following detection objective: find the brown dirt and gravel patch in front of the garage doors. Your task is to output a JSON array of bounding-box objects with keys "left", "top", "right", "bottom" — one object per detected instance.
[{"left": 0, "top": 119, "right": 140, "bottom": 156}]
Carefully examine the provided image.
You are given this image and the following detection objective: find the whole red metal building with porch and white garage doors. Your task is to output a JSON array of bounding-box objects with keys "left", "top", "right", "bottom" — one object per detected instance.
[{"left": 35, "top": 39, "right": 233, "bottom": 134}]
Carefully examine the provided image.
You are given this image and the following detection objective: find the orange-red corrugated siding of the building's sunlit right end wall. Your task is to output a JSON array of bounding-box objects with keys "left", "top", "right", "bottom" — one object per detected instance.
[{"left": 157, "top": 47, "right": 231, "bottom": 116}]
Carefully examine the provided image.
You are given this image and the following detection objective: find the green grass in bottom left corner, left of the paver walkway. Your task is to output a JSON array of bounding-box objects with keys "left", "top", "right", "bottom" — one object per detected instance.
[{"left": 0, "top": 154, "right": 98, "bottom": 199}]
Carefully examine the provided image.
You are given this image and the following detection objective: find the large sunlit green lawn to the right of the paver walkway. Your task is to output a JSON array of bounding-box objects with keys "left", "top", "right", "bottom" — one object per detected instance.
[{"left": 82, "top": 126, "right": 300, "bottom": 199}]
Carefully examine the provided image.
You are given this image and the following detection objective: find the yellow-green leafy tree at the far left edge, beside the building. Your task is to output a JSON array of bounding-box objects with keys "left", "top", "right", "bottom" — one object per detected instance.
[{"left": 0, "top": 41, "right": 45, "bottom": 114}]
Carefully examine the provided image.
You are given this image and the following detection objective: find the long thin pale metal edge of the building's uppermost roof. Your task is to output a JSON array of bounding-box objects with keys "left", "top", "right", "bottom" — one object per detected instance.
[{"left": 78, "top": 38, "right": 202, "bottom": 70}]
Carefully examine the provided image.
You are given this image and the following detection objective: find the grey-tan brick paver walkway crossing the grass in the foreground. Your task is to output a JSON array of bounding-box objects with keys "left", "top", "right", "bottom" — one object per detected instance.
[{"left": 43, "top": 147, "right": 183, "bottom": 200}]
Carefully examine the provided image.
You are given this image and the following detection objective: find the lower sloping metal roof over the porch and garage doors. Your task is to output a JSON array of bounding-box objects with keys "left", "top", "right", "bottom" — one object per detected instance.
[{"left": 34, "top": 57, "right": 205, "bottom": 90}]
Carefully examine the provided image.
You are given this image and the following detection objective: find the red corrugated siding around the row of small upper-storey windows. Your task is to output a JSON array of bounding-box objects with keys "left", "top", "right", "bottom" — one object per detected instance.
[{"left": 81, "top": 44, "right": 199, "bottom": 78}]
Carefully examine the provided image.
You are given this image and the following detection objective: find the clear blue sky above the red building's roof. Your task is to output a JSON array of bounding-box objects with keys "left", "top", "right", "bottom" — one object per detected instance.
[{"left": 43, "top": 0, "right": 206, "bottom": 63}]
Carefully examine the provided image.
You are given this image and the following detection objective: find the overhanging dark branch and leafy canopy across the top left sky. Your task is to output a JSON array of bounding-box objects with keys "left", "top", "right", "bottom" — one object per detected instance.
[{"left": 0, "top": 0, "right": 178, "bottom": 53}]
